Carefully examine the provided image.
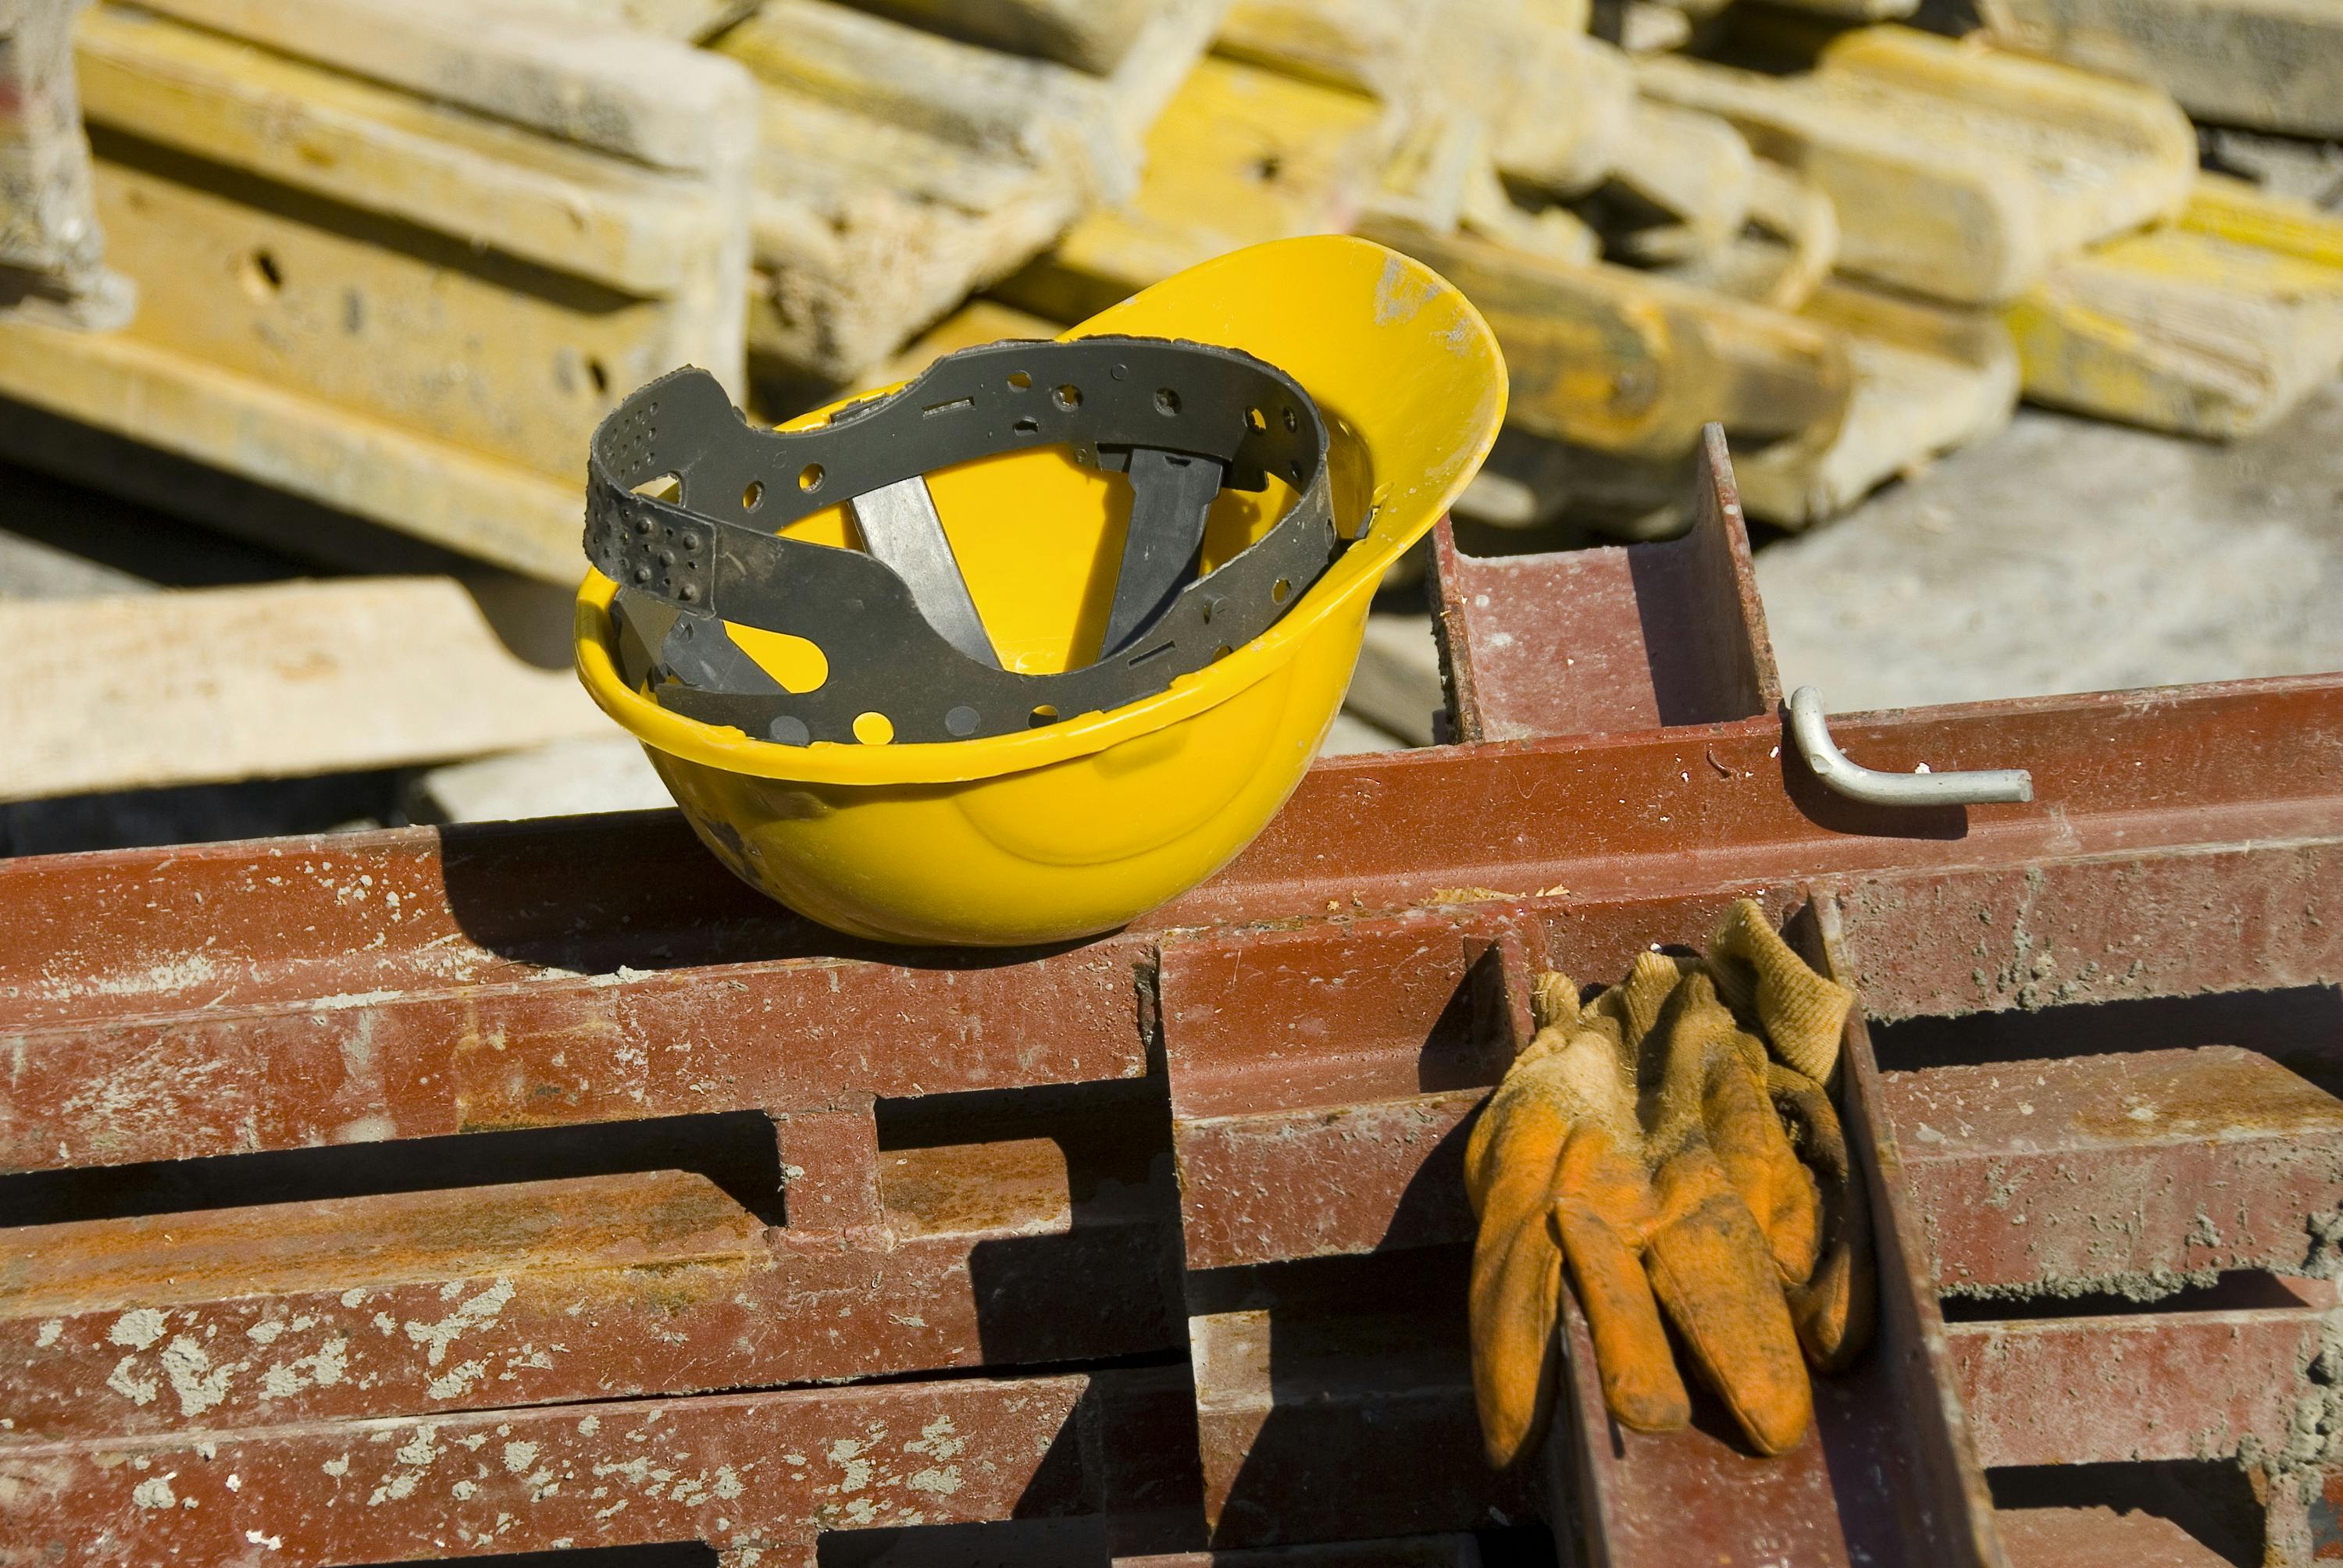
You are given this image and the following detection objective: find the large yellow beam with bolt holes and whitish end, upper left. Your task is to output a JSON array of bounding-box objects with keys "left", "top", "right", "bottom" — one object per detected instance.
[{"left": 0, "top": 0, "right": 754, "bottom": 581}]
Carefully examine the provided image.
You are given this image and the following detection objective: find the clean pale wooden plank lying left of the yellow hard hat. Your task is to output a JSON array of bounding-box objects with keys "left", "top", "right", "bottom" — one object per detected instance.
[{"left": 0, "top": 576, "right": 607, "bottom": 800}]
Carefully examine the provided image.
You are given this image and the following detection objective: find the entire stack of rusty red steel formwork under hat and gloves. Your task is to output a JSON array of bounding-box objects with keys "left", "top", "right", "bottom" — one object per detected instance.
[{"left": 0, "top": 429, "right": 2343, "bottom": 1568}]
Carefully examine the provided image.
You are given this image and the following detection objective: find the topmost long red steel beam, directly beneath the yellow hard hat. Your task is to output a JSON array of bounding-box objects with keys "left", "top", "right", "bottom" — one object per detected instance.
[{"left": 0, "top": 677, "right": 2343, "bottom": 1185}]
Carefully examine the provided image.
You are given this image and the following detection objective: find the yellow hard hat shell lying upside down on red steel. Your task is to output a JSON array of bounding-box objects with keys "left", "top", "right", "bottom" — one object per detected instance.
[{"left": 576, "top": 237, "right": 1504, "bottom": 947}]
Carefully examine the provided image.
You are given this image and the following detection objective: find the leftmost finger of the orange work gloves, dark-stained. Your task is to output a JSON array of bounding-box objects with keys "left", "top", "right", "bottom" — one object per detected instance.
[{"left": 1467, "top": 1207, "right": 1563, "bottom": 1470}]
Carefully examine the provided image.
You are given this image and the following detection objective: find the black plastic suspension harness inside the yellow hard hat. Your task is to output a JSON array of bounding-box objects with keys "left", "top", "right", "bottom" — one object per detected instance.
[{"left": 586, "top": 337, "right": 1345, "bottom": 745}]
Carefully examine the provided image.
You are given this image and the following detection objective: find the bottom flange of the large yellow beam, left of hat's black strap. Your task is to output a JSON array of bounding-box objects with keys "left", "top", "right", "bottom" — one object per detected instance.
[{"left": 0, "top": 323, "right": 583, "bottom": 586}]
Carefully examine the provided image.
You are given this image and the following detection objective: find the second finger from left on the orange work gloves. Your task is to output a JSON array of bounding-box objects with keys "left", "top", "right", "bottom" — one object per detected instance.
[{"left": 1553, "top": 1128, "right": 1692, "bottom": 1432}]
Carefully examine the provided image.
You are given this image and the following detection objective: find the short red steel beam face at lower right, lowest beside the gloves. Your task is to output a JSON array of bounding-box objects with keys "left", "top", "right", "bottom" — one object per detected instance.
[{"left": 1952, "top": 1287, "right": 2334, "bottom": 1465}]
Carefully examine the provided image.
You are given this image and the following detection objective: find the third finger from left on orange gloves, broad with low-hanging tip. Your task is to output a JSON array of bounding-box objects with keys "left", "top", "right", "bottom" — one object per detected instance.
[{"left": 1642, "top": 1146, "right": 1813, "bottom": 1453}]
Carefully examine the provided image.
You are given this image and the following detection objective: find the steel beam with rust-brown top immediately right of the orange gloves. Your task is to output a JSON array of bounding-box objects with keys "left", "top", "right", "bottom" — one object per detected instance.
[{"left": 1886, "top": 1041, "right": 2343, "bottom": 1299}]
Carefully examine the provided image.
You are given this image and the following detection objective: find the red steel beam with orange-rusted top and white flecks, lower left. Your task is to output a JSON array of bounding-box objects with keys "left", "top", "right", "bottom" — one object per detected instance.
[{"left": 0, "top": 1120, "right": 1181, "bottom": 1439}]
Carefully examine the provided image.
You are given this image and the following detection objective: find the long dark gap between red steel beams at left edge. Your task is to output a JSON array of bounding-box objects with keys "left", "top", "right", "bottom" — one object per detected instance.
[{"left": 0, "top": 1111, "right": 783, "bottom": 1226}]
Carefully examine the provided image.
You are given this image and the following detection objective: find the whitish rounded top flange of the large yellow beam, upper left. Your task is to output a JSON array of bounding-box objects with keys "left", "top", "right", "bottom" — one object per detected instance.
[{"left": 130, "top": 0, "right": 754, "bottom": 171}]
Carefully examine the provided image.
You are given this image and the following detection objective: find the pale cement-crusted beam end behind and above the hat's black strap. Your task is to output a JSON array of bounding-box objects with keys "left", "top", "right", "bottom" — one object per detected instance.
[{"left": 717, "top": 0, "right": 1225, "bottom": 382}]
